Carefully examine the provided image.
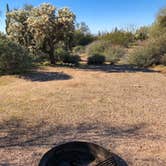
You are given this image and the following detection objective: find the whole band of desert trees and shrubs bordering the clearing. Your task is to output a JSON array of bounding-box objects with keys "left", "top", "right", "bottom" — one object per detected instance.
[{"left": 0, "top": 4, "right": 166, "bottom": 73}]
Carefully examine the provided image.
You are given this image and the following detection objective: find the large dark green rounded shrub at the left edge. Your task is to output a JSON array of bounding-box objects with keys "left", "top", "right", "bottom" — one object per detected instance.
[{"left": 0, "top": 38, "right": 31, "bottom": 74}]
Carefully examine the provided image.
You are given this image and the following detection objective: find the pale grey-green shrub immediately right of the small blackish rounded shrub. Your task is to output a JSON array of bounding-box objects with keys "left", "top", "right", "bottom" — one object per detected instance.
[{"left": 105, "top": 46, "right": 125, "bottom": 64}]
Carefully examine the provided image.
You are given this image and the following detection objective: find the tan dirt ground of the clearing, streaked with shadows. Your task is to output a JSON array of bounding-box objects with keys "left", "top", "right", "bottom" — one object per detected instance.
[{"left": 0, "top": 66, "right": 166, "bottom": 166}]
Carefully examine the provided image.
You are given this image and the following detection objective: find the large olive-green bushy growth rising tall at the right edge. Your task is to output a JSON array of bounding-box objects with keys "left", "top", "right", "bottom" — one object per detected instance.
[{"left": 128, "top": 8, "right": 166, "bottom": 67}]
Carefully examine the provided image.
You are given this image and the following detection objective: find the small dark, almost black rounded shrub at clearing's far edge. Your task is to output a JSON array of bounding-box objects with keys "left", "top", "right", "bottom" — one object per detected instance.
[{"left": 88, "top": 54, "right": 105, "bottom": 65}]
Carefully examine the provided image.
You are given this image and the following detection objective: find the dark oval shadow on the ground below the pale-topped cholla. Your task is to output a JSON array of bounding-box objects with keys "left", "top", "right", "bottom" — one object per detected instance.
[{"left": 18, "top": 71, "right": 72, "bottom": 82}]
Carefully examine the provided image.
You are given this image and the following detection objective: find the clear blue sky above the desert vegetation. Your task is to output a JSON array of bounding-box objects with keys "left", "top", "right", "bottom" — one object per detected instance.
[{"left": 0, "top": 0, "right": 166, "bottom": 34}]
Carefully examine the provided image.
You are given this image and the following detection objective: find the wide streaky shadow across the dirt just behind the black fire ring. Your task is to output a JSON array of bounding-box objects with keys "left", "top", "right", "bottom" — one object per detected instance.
[{"left": 0, "top": 119, "right": 146, "bottom": 148}]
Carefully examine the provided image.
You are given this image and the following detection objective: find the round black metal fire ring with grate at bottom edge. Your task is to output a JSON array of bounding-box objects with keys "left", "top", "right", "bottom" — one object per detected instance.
[{"left": 39, "top": 142, "right": 127, "bottom": 166}]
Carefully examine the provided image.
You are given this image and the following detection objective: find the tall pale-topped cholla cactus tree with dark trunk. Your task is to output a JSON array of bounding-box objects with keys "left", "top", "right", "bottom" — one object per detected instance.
[{"left": 7, "top": 3, "right": 75, "bottom": 64}]
